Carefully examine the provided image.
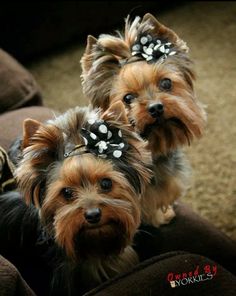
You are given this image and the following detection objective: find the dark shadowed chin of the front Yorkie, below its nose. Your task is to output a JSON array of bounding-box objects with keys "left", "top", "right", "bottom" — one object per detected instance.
[{"left": 75, "top": 221, "right": 129, "bottom": 260}]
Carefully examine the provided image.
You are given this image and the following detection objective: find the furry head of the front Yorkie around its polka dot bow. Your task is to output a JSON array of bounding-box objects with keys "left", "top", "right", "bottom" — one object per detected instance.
[{"left": 17, "top": 103, "right": 151, "bottom": 261}]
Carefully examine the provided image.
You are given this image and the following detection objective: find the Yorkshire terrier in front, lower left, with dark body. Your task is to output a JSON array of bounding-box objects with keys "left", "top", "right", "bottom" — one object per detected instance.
[{"left": 0, "top": 102, "right": 152, "bottom": 295}]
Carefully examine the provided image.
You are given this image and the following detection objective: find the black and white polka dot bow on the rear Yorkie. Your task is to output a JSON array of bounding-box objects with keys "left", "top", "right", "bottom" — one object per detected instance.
[{"left": 132, "top": 34, "right": 176, "bottom": 63}]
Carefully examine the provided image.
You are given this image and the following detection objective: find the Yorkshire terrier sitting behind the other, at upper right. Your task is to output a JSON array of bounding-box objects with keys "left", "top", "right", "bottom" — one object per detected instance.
[{"left": 81, "top": 13, "right": 206, "bottom": 226}]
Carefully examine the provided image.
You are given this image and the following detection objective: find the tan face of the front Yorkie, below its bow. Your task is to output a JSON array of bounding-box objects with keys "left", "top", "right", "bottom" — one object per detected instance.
[{"left": 41, "top": 154, "right": 140, "bottom": 258}]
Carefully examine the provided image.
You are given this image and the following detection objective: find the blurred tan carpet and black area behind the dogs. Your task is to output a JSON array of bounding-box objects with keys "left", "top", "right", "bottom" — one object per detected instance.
[{"left": 0, "top": 1, "right": 236, "bottom": 239}]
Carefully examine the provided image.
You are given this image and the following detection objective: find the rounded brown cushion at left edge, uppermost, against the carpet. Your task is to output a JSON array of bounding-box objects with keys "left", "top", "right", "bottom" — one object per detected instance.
[{"left": 0, "top": 49, "right": 42, "bottom": 113}]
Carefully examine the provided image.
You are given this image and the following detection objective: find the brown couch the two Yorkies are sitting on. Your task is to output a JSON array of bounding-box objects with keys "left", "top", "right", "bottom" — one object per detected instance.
[{"left": 0, "top": 51, "right": 236, "bottom": 296}]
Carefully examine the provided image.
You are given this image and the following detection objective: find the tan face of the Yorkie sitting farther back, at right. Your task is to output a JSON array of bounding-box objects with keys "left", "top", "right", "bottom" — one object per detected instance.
[{"left": 110, "top": 58, "right": 205, "bottom": 154}]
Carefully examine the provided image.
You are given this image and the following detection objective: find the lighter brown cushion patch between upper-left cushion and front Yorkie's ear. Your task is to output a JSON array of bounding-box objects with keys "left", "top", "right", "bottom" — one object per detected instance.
[{"left": 0, "top": 106, "right": 54, "bottom": 150}]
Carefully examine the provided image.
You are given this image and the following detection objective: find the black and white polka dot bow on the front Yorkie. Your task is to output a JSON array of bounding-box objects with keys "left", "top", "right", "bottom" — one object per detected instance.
[{"left": 81, "top": 119, "right": 128, "bottom": 158}]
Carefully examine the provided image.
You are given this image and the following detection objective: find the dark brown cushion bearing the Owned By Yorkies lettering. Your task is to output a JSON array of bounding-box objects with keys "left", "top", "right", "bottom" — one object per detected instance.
[{"left": 84, "top": 252, "right": 236, "bottom": 296}]
